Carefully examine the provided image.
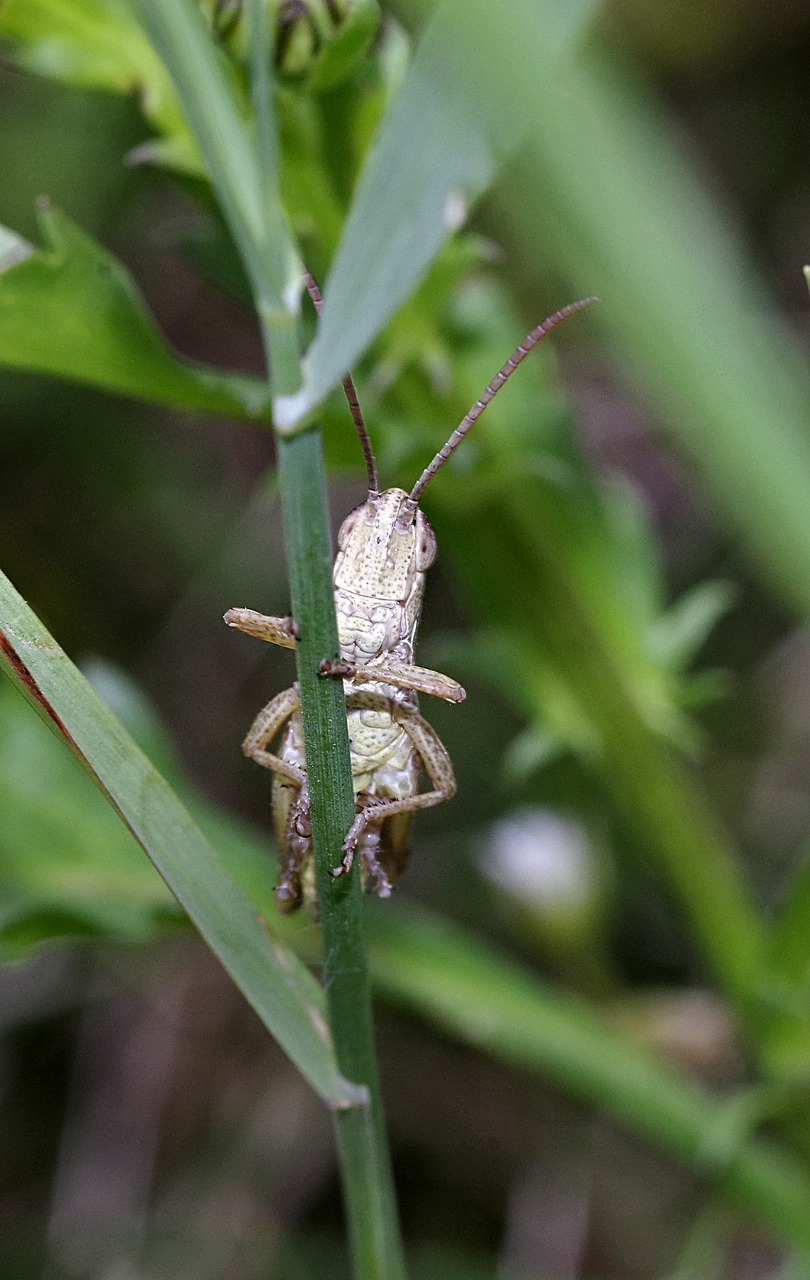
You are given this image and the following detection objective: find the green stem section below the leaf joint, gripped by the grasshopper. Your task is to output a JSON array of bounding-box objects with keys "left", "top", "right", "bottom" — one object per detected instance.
[{"left": 279, "top": 430, "right": 404, "bottom": 1280}]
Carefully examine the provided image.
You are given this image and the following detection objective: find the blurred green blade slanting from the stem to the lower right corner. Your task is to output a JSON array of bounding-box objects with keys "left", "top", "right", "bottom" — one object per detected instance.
[{"left": 370, "top": 905, "right": 810, "bottom": 1260}]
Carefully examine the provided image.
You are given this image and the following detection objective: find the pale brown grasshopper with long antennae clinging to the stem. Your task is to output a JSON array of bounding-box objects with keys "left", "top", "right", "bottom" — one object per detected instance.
[{"left": 225, "top": 273, "right": 594, "bottom": 915}]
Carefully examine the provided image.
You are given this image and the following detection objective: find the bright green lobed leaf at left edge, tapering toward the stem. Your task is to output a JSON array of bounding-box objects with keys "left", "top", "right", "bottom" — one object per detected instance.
[{"left": 0, "top": 206, "right": 267, "bottom": 419}]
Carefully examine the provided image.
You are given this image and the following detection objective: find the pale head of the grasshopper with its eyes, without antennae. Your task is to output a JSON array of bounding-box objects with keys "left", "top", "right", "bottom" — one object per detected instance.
[{"left": 334, "top": 489, "right": 436, "bottom": 602}]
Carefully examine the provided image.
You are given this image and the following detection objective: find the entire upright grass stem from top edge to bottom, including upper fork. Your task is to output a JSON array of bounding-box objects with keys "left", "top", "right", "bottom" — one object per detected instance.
[{"left": 138, "top": 0, "right": 404, "bottom": 1259}]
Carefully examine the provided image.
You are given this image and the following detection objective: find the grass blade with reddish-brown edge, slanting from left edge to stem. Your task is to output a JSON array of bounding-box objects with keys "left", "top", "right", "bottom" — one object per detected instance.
[{"left": 0, "top": 565, "right": 352, "bottom": 1105}]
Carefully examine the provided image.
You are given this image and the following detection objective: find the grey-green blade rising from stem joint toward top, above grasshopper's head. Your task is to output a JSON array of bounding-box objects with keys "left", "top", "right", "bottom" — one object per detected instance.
[{"left": 306, "top": 0, "right": 591, "bottom": 404}]
